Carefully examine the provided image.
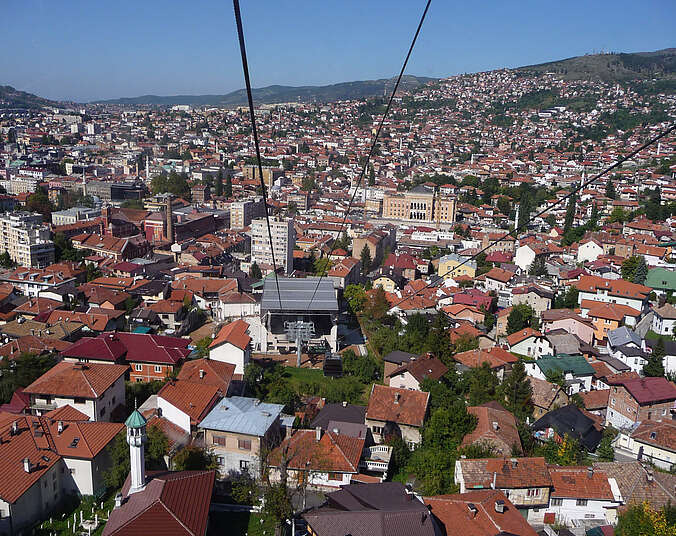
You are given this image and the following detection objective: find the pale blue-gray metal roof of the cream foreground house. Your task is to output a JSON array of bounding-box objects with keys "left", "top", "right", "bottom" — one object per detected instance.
[{"left": 199, "top": 396, "right": 284, "bottom": 437}]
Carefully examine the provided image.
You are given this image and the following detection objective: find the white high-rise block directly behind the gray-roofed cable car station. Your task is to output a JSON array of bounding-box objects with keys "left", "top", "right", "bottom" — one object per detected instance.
[{"left": 251, "top": 218, "right": 296, "bottom": 274}]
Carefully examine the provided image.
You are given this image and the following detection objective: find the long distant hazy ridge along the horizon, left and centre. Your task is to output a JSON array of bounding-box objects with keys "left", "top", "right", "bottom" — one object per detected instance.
[{"left": 94, "top": 76, "right": 434, "bottom": 106}]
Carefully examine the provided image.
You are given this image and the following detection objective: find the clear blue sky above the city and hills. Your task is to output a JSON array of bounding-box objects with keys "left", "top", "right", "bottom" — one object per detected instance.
[{"left": 0, "top": 0, "right": 676, "bottom": 102}]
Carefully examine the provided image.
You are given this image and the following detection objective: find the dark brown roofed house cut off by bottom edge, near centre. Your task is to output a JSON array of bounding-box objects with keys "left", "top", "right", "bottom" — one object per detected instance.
[{"left": 302, "top": 482, "right": 441, "bottom": 536}]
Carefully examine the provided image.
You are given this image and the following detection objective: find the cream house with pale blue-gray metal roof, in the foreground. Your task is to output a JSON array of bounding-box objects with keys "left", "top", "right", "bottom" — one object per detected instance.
[{"left": 199, "top": 396, "right": 284, "bottom": 475}]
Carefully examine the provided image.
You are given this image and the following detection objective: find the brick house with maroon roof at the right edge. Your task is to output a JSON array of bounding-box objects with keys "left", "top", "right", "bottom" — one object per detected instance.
[{"left": 606, "top": 375, "right": 676, "bottom": 428}]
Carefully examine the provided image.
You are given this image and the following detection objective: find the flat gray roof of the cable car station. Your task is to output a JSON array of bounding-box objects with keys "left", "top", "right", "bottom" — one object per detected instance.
[{"left": 261, "top": 276, "right": 338, "bottom": 313}]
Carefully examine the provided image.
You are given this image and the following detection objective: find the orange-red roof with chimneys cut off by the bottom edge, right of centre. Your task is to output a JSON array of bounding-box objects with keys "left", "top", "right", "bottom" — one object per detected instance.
[{"left": 426, "top": 490, "right": 537, "bottom": 536}]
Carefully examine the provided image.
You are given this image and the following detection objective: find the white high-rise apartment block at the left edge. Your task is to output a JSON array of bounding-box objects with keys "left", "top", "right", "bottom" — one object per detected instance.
[{"left": 0, "top": 212, "right": 54, "bottom": 268}]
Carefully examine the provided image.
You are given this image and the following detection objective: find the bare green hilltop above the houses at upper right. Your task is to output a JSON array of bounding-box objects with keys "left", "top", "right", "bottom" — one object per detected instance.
[{"left": 516, "top": 48, "right": 676, "bottom": 82}]
